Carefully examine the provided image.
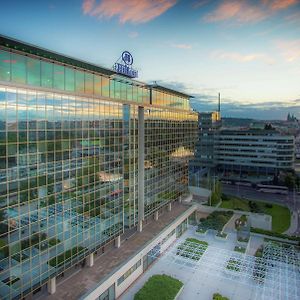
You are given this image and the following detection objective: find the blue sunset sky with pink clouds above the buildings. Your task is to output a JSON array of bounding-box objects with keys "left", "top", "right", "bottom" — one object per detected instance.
[{"left": 0, "top": 0, "right": 300, "bottom": 119}]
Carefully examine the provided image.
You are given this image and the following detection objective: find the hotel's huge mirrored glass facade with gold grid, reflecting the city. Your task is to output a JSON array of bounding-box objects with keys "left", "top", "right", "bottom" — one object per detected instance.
[{"left": 0, "top": 41, "right": 197, "bottom": 299}]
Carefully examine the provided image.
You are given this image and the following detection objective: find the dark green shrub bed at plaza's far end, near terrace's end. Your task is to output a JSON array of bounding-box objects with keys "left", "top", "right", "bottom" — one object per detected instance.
[{"left": 197, "top": 211, "right": 233, "bottom": 232}]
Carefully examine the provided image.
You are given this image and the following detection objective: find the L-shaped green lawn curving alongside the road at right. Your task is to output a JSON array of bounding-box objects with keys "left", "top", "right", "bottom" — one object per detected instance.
[{"left": 220, "top": 197, "right": 291, "bottom": 233}]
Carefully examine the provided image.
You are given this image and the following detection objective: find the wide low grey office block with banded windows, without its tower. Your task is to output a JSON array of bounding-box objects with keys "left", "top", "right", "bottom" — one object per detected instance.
[{"left": 214, "top": 129, "right": 295, "bottom": 174}]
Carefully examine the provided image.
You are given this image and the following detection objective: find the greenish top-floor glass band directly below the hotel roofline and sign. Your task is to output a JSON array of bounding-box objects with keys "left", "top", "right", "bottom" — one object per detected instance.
[{"left": 0, "top": 48, "right": 190, "bottom": 110}]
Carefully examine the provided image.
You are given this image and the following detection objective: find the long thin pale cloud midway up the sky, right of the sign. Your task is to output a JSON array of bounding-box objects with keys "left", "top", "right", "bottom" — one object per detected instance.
[{"left": 211, "top": 51, "right": 274, "bottom": 64}]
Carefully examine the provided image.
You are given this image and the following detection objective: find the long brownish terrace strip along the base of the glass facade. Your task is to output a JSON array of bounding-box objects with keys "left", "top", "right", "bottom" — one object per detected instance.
[{"left": 39, "top": 203, "right": 190, "bottom": 300}]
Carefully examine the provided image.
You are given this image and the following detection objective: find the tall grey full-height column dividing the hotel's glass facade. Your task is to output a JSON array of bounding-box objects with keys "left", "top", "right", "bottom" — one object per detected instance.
[{"left": 138, "top": 106, "right": 145, "bottom": 232}]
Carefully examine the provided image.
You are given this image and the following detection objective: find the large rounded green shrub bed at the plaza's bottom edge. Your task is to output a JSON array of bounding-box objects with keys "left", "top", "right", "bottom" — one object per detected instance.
[{"left": 134, "top": 275, "right": 183, "bottom": 300}]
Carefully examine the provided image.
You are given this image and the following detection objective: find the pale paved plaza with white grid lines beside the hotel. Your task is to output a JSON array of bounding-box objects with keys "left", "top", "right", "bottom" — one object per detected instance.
[{"left": 120, "top": 227, "right": 300, "bottom": 300}]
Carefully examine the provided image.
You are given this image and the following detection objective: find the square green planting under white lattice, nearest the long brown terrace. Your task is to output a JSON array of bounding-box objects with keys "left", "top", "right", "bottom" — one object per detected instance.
[{"left": 176, "top": 238, "right": 208, "bottom": 260}]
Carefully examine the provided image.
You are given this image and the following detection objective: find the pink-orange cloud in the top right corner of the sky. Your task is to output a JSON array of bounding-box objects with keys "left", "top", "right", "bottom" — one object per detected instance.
[{"left": 204, "top": 0, "right": 299, "bottom": 23}]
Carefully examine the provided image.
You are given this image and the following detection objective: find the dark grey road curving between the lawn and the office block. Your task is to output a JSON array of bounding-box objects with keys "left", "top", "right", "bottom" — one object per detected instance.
[{"left": 222, "top": 183, "right": 300, "bottom": 235}]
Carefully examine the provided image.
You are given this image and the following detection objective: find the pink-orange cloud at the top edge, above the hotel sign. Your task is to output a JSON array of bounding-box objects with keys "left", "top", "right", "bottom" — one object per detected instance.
[{"left": 82, "top": 0, "right": 177, "bottom": 24}]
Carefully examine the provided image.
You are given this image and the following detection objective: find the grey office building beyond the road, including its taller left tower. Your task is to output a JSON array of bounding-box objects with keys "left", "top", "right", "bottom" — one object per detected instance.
[{"left": 191, "top": 112, "right": 295, "bottom": 174}]
